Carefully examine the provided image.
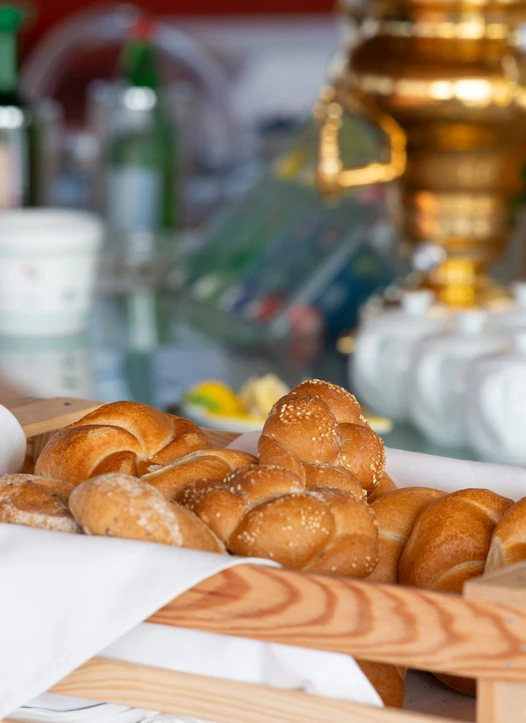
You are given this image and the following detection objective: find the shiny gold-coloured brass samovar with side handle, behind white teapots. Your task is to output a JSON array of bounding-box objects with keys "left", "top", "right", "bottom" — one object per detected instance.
[{"left": 317, "top": 0, "right": 526, "bottom": 307}]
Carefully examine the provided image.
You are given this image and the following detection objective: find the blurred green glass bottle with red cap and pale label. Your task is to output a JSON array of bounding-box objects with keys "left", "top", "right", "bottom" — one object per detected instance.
[{"left": 106, "top": 21, "right": 179, "bottom": 258}]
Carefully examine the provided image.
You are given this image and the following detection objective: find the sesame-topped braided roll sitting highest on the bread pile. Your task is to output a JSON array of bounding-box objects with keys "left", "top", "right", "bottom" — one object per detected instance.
[{"left": 258, "top": 380, "right": 385, "bottom": 493}]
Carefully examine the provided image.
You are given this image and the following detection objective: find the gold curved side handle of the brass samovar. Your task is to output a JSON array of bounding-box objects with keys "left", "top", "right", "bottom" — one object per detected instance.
[{"left": 315, "top": 86, "right": 406, "bottom": 196}]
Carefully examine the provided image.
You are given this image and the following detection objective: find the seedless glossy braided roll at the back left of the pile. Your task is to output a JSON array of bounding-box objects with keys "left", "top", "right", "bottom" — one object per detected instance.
[{"left": 35, "top": 402, "right": 211, "bottom": 485}]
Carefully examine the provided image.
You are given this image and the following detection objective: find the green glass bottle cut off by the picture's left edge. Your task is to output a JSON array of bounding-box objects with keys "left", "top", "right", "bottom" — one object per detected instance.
[{"left": 0, "top": 4, "right": 38, "bottom": 210}]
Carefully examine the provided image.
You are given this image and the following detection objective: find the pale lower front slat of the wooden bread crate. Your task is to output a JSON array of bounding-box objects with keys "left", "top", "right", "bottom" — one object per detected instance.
[{"left": 47, "top": 658, "right": 453, "bottom": 723}]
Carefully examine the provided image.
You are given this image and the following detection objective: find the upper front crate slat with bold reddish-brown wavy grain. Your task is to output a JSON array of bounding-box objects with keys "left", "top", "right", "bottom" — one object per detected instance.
[{"left": 145, "top": 565, "right": 526, "bottom": 682}]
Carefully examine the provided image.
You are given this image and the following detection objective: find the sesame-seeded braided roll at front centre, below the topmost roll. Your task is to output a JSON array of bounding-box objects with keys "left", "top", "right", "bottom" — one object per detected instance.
[{"left": 178, "top": 464, "right": 378, "bottom": 577}]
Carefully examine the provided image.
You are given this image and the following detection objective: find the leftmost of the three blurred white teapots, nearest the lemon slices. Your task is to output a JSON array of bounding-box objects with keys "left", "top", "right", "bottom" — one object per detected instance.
[{"left": 349, "top": 290, "right": 448, "bottom": 422}]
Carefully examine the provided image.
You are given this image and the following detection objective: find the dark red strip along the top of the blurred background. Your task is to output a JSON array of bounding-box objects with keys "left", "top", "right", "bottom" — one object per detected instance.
[{"left": 23, "top": 0, "right": 334, "bottom": 55}]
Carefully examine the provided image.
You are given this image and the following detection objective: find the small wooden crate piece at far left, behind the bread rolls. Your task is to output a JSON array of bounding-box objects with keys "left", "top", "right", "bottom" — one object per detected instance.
[{"left": 9, "top": 397, "right": 102, "bottom": 439}]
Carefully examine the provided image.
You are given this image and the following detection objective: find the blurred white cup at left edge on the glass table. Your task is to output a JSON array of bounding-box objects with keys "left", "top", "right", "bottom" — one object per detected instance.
[{"left": 0, "top": 208, "right": 103, "bottom": 336}]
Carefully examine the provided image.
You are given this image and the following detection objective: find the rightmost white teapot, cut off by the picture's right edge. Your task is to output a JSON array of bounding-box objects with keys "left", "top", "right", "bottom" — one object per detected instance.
[{"left": 466, "top": 330, "right": 526, "bottom": 466}]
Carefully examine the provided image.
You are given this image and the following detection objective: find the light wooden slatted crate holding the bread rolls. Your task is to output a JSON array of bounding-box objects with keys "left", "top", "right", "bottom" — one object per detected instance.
[{"left": 4, "top": 399, "right": 526, "bottom": 723}]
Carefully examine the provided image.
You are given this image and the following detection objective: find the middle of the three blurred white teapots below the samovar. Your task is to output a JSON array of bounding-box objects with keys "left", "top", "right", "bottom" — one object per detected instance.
[{"left": 409, "top": 311, "right": 510, "bottom": 447}]
